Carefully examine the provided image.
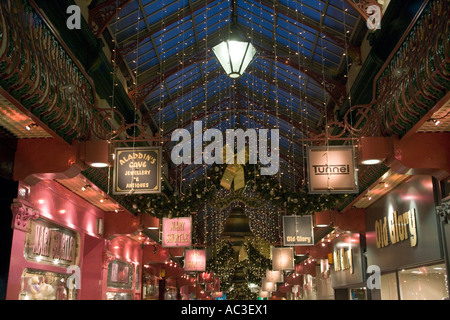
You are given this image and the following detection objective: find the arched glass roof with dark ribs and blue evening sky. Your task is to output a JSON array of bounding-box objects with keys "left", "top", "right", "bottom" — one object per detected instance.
[{"left": 108, "top": 0, "right": 359, "bottom": 188}]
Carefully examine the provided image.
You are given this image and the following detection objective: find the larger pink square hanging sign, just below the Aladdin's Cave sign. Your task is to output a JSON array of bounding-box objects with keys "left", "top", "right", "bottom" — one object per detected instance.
[{"left": 162, "top": 217, "right": 192, "bottom": 247}]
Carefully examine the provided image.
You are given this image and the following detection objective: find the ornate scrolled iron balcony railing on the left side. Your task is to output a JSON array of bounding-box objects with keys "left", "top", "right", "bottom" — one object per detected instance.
[{"left": 0, "top": 0, "right": 96, "bottom": 142}]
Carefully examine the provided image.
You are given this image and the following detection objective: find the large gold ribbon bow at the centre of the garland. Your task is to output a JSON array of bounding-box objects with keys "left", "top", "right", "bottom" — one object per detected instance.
[{"left": 220, "top": 144, "right": 249, "bottom": 191}]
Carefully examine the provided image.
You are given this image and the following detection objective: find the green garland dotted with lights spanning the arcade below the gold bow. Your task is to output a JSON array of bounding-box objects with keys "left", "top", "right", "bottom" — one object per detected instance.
[{"left": 117, "top": 164, "right": 348, "bottom": 218}]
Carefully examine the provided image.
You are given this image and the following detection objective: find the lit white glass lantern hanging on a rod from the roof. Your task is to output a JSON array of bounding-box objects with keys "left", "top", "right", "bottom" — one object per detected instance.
[{"left": 212, "top": 1, "right": 256, "bottom": 78}]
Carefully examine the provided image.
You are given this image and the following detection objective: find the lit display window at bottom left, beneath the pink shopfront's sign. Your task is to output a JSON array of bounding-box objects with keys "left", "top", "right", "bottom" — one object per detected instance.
[{"left": 19, "top": 269, "right": 77, "bottom": 300}]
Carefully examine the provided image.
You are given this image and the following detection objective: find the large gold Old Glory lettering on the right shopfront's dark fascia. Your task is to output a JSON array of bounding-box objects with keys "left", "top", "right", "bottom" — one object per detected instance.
[{"left": 375, "top": 208, "right": 417, "bottom": 248}]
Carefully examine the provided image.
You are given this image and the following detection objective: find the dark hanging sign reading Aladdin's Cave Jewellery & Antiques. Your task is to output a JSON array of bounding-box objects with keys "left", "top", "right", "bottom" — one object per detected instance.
[{"left": 113, "top": 147, "right": 162, "bottom": 194}]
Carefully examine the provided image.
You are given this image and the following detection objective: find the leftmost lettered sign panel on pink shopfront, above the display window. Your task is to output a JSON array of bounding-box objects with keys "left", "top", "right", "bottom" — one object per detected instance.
[{"left": 24, "top": 218, "right": 79, "bottom": 266}]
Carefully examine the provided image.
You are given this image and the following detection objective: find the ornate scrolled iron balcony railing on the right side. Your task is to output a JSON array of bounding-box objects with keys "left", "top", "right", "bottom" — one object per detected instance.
[{"left": 318, "top": 1, "right": 450, "bottom": 140}]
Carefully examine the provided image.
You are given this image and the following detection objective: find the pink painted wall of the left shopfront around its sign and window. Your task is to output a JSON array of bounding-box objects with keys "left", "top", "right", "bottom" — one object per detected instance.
[{"left": 6, "top": 180, "right": 104, "bottom": 300}]
